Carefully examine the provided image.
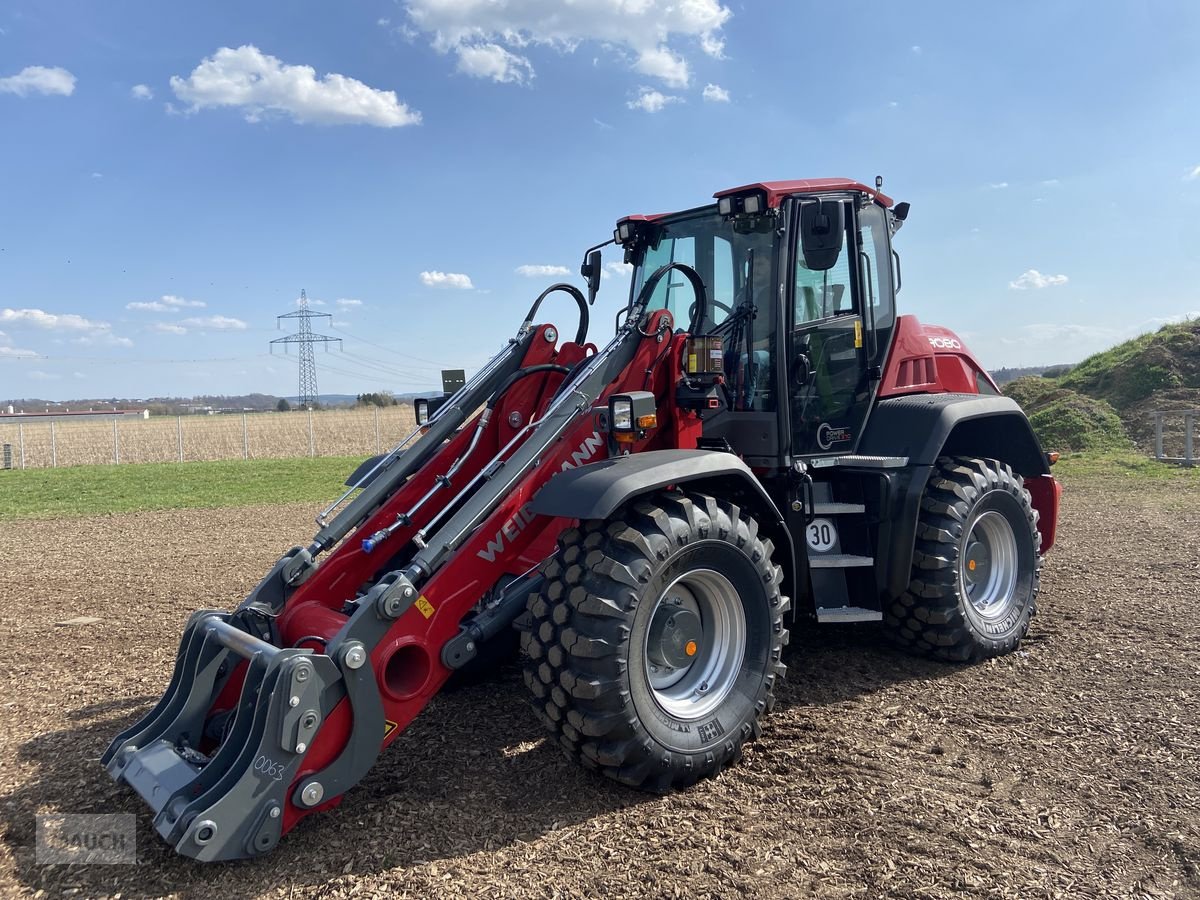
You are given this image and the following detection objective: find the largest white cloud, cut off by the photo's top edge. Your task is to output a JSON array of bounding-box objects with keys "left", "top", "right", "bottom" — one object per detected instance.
[{"left": 404, "top": 0, "right": 733, "bottom": 88}]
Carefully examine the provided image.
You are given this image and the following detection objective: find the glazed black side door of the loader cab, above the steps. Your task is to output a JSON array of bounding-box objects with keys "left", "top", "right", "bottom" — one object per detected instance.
[{"left": 787, "top": 198, "right": 893, "bottom": 456}]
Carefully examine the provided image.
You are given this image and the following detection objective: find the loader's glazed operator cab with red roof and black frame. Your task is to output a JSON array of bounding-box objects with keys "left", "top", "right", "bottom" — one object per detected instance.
[{"left": 617, "top": 179, "right": 907, "bottom": 468}]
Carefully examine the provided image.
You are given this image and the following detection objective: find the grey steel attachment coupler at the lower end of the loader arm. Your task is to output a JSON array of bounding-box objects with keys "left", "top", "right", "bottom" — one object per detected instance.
[{"left": 101, "top": 610, "right": 367, "bottom": 862}]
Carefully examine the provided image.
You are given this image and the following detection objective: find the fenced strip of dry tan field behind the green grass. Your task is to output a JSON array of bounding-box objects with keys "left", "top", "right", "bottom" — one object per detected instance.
[{"left": 0, "top": 406, "right": 416, "bottom": 469}]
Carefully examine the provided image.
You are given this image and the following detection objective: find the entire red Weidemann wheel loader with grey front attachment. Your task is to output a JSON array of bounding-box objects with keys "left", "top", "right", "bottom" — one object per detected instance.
[{"left": 103, "top": 179, "right": 1061, "bottom": 860}]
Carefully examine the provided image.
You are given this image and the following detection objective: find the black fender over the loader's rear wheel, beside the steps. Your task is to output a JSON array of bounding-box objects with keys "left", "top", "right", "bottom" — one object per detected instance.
[{"left": 858, "top": 394, "right": 1050, "bottom": 598}]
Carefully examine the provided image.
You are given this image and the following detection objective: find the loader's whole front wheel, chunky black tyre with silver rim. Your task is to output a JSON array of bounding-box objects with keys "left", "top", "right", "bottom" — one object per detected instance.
[{"left": 522, "top": 492, "right": 790, "bottom": 792}]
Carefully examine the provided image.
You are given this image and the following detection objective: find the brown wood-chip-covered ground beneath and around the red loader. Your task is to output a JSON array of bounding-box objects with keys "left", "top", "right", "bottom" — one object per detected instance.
[{"left": 0, "top": 482, "right": 1200, "bottom": 898}]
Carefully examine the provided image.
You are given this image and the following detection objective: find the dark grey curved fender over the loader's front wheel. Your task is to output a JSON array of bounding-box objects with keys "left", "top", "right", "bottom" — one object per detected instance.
[{"left": 529, "top": 450, "right": 796, "bottom": 609}]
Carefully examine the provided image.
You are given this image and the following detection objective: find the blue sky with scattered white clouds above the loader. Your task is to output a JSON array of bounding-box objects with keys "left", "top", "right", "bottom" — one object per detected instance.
[{"left": 0, "top": 0, "right": 1200, "bottom": 400}]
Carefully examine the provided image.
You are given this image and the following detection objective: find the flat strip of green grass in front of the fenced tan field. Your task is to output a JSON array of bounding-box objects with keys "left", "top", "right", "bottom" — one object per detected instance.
[{"left": 0, "top": 457, "right": 361, "bottom": 520}]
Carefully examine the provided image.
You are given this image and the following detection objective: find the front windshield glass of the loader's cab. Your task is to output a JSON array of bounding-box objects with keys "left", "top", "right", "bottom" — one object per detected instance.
[{"left": 634, "top": 209, "right": 778, "bottom": 410}]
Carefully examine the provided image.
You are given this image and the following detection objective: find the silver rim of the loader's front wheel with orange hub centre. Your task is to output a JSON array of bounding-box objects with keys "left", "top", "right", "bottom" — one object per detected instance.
[{"left": 642, "top": 569, "right": 746, "bottom": 719}]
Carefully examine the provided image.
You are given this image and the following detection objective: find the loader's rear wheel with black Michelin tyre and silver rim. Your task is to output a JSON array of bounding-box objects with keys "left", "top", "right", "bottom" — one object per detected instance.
[{"left": 883, "top": 457, "right": 1042, "bottom": 661}]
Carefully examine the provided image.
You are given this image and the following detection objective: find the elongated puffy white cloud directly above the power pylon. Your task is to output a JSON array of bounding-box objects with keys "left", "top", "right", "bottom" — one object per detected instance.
[{"left": 170, "top": 44, "right": 421, "bottom": 128}]
